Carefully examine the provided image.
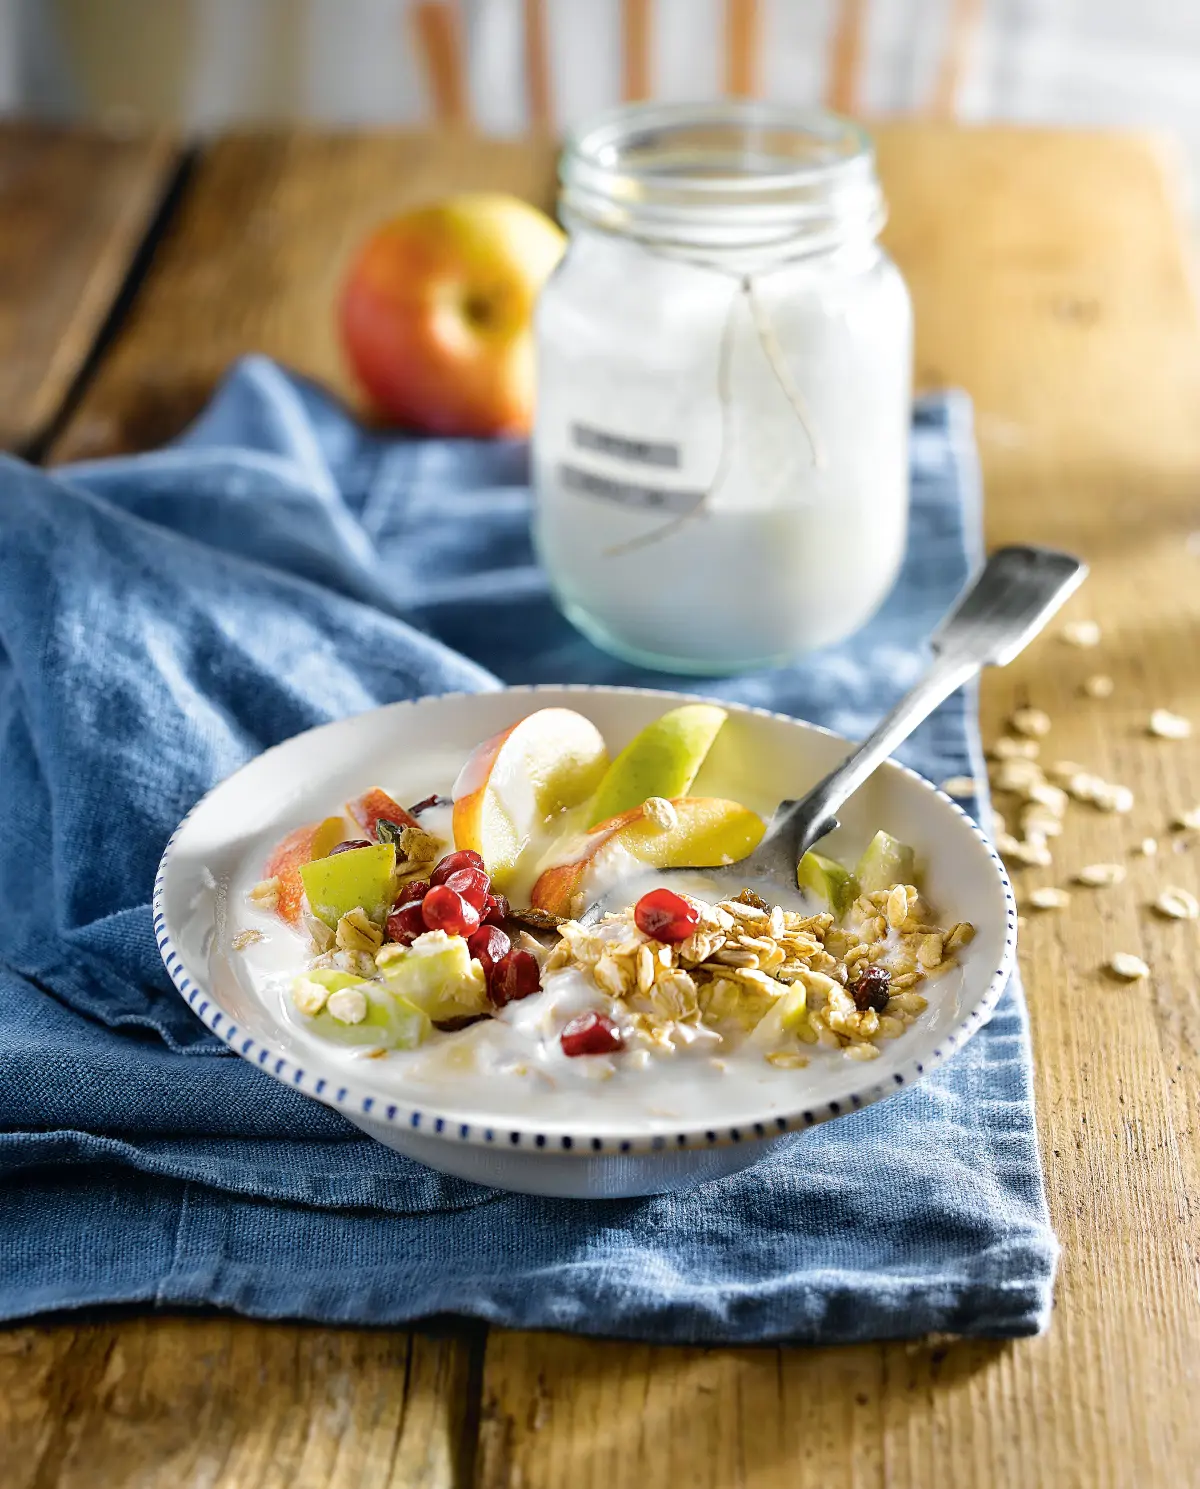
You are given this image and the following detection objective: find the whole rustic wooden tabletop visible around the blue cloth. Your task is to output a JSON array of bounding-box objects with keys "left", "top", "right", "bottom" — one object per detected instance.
[{"left": 0, "top": 124, "right": 1200, "bottom": 1489}]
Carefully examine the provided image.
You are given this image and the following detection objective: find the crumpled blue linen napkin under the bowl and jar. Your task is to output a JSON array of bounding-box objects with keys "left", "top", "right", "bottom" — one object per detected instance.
[{"left": 0, "top": 359, "right": 1057, "bottom": 1343}]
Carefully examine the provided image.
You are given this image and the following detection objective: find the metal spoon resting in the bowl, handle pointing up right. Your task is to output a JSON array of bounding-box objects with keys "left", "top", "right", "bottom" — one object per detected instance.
[{"left": 579, "top": 548, "right": 1087, "bottom": 925}]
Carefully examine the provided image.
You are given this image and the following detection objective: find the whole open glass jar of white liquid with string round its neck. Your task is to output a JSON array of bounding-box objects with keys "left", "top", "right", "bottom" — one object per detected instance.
[{"left": 533, "top": 101, "right": 913, "bottom": 673}]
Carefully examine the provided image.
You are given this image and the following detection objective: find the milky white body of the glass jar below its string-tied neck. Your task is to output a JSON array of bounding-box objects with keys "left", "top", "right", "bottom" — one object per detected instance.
[{"left": 533, "top": 234, "right": 911, "bottom": 672}]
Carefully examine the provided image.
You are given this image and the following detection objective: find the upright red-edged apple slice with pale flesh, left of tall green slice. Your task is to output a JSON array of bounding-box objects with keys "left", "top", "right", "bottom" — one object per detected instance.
[{"left": 454, "top": 709, "right": 609, "bottom": 890}]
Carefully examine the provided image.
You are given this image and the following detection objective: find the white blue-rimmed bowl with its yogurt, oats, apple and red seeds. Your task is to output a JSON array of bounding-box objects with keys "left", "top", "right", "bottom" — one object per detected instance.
[{"left": 155, "top": 688, "right": 1015, "bottom": 1197}]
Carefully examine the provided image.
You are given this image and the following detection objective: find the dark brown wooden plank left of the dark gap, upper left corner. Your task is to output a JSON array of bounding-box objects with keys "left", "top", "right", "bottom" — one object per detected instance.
[{"left": 0, "top": 122, "right": 179, "bottom": 450}]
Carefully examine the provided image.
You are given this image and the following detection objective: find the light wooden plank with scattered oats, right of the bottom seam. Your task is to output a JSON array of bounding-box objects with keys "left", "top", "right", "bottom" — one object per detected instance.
[{"left": 479, "top": 125, "right": 1200, "bottom": 1489}]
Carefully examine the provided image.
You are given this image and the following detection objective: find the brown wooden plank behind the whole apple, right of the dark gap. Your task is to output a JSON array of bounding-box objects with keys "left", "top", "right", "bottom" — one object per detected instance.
[{"left": 54, "top": 134, "right": 555, "bottom": 460}]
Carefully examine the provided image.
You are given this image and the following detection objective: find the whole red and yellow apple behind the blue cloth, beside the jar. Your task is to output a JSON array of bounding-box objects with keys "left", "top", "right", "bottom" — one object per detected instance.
[{"left": 338, "top": 194, "right": 566, "bottom": 436}]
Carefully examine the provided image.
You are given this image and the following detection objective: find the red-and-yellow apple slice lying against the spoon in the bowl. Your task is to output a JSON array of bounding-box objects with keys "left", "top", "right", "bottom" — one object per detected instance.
[{"left": 530, "top": 797, "right": 765, "bottom": 916}]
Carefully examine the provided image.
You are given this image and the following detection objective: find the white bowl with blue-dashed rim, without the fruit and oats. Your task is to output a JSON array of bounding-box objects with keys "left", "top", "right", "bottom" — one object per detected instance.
[{"left": 153, "top": 686, "right": 1017, "bottom": 1199}]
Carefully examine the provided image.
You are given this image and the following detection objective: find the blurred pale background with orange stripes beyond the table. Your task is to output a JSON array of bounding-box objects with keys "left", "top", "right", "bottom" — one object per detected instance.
[{"left": 0, "top": 0, "right": 1200, "bottom": 217}]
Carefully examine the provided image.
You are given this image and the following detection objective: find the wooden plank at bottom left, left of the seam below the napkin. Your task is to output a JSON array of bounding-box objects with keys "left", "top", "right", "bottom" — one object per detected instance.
[{"left": 0, "top": 1318, "right": 475, "bottom": 1489}]
